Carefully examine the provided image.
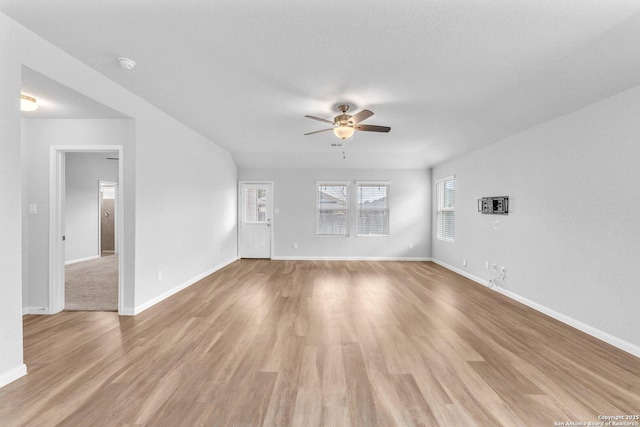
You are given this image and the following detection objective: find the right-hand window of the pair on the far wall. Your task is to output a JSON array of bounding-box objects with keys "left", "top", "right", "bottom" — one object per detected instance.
[{"left": 356, "top": 182, "right": 389, "bottom": 236}]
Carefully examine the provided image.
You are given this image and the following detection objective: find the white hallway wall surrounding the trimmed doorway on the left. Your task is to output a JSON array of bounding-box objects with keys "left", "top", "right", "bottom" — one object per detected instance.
[{"left": 23, "top": 119, "right": 136, "bottom": 312}]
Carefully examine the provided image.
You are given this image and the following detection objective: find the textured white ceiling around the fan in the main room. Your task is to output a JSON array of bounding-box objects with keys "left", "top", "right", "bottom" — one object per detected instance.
[{"left": 5, "top": 0, "right": 640, "bottom": 168}]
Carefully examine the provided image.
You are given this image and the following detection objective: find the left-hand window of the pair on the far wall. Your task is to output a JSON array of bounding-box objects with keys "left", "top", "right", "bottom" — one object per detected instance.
[{"left": 316, "top": 183, "right": 349, "bottom": 236}]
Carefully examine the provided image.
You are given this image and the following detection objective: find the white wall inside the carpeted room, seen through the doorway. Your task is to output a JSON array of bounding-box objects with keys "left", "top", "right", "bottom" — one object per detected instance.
[{"left": 65, "top": 152, "right": 118, "bottom": 262}]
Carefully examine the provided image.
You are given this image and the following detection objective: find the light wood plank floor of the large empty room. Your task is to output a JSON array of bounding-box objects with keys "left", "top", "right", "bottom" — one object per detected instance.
[{"left": 0, "top": 260, "right": 640, "bottom": 426}]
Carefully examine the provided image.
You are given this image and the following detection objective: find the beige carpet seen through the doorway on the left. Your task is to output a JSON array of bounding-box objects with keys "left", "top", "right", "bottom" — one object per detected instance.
[{"left": 64, "top": 255, "right": 118, "bottom": 311}]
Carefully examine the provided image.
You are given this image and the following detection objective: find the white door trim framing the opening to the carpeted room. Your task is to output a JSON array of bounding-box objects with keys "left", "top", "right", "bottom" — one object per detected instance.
[{"left": 47, "top": 145, "right": 125, "bottom": 315}]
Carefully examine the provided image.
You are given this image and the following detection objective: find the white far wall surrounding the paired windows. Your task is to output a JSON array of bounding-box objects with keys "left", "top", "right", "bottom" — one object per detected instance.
[{"left": 238, "top": 169, "right": 431, "bottom": 259}]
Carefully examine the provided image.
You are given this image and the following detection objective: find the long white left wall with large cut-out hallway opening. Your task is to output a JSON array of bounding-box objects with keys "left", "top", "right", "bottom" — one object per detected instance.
[{"left": 0, "top": 14, "right": 237, "bottom": 388}]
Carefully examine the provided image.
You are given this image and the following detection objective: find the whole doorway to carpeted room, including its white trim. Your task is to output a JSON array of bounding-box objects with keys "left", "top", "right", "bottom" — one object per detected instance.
[{"left": 49, "top": 145, "right": 124, "bottom": 314}]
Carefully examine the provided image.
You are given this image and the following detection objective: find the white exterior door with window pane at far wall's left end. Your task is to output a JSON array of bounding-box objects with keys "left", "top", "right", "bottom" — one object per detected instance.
[{"left": 239, "top": 182, "right": 272, "bottom": 258}]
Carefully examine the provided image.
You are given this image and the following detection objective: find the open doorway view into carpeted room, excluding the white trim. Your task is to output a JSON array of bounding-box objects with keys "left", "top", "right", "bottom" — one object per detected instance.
[{"left": 64, "top": 166, "right": 119, "bottom": 311}]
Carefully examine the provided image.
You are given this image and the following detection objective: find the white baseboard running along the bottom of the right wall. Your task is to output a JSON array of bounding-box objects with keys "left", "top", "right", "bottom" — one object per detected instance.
[{"left": 433, "top": 259, "right": 640, "bottom": 357}]
